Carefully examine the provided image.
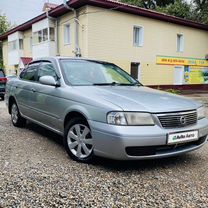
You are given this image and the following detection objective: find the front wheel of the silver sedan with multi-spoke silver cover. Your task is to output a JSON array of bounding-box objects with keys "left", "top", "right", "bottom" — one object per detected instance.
[{"left": 64, "top": 117, "right": 94, "bottom": 163}]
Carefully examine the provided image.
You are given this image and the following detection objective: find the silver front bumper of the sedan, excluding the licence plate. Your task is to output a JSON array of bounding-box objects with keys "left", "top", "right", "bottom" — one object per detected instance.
[{"left": 89, "top": 119, "right": 208, "bottom": 160}]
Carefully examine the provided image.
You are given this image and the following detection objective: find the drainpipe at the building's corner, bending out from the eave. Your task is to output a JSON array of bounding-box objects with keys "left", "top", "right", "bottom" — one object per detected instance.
[{"left": 63, "top": 0, "right": 81, "bottom": 57}]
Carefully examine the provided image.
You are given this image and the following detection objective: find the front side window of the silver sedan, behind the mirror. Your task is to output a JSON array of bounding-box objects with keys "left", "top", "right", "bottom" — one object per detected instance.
[{"left": 38, "top": 62, "right": 58, "bottom": 81}]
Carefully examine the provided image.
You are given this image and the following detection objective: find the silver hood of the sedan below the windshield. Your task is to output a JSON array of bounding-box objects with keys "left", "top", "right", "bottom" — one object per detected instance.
[{"left": 74, "top": 86, "right": 201, "bottom": 113}]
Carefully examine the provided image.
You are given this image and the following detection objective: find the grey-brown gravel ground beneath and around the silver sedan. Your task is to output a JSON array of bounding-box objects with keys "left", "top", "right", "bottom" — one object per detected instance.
[{"left": 0, "top": 98, "right": 208, "bottom": 208}]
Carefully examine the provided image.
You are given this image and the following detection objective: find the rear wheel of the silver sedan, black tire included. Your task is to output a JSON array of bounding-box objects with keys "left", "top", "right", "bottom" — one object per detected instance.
[{"left": 11, "top": 102, "right": 26, "bottom": 127}]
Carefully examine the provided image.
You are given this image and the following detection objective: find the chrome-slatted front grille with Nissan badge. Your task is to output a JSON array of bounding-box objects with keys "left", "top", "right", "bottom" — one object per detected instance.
[{"left": 157, "top": 111, "right": 197, "bottom": 128}]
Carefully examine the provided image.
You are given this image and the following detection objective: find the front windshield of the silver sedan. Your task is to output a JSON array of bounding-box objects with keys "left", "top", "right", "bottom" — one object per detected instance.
[{"left": 61, "top": 59, "right": 140, "bottom": 86}]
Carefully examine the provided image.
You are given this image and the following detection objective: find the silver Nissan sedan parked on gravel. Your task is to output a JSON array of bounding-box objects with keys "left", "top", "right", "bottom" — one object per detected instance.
[{"left": 6, "top": 57, "right": 208, "bottom": 162}]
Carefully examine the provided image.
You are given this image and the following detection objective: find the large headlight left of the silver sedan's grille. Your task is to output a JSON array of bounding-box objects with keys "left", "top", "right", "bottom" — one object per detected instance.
[{"left": 107, "top": 112, "right": 154, "bottom": 126}]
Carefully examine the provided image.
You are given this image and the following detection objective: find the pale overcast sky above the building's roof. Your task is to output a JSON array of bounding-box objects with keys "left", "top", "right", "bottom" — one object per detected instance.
[{"left": 0, "top": 0, "right": 190, "bottom": 25}]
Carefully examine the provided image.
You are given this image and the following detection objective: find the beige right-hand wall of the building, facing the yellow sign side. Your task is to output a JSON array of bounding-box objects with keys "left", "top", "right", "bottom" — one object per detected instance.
[{"left": 87, "top": 6, "right": 208, "bottom": 85}]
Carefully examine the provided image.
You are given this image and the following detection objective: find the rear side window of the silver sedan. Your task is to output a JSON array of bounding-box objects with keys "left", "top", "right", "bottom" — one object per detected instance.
[{"left": 20, "top": 63, "right": 39, "bottom": 82}]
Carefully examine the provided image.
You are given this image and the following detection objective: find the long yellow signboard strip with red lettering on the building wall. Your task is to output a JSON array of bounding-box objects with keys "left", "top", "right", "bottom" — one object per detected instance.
[{"left": 156, "top": 56, "right": 208, "bottom": 67}]
